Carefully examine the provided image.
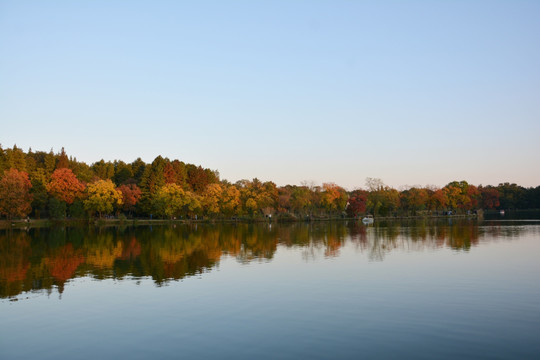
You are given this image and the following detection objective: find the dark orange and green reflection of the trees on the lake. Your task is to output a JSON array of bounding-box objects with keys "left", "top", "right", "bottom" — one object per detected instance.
[{"left": 0, "top": 220, "right": 520, "bottom": 298}]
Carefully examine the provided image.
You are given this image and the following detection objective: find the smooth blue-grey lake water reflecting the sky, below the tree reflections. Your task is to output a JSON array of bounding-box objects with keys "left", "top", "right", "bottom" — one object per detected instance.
[{"left": 0, "top": 225, "right": 540, "bottom": 359}]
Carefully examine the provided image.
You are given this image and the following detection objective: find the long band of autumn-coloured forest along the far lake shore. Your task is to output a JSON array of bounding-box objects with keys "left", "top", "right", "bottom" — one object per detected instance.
[{"left": 0, "top": 146, "right": 540, "bottom": 220}]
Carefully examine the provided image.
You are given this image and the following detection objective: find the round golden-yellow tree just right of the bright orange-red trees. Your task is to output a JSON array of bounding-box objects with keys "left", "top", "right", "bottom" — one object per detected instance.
[{"left": 84, "top": 179, "right": 122, "bottom": 218}]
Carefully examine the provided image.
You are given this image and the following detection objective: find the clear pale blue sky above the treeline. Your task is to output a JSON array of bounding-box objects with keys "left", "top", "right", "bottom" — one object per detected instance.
[{"left": 0, "top": 0, "right": 540, "bottom": 189}]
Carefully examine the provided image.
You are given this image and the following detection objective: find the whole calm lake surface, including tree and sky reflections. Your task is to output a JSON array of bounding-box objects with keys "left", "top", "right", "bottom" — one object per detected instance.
[{"left": 0, "top": 220, "right": 540, "bottom": 359}]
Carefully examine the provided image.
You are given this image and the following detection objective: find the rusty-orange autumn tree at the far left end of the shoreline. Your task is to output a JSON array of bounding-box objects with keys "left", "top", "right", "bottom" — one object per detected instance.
[{"left": 0, "top": 169, "right": 32, "bottom": 220}]
